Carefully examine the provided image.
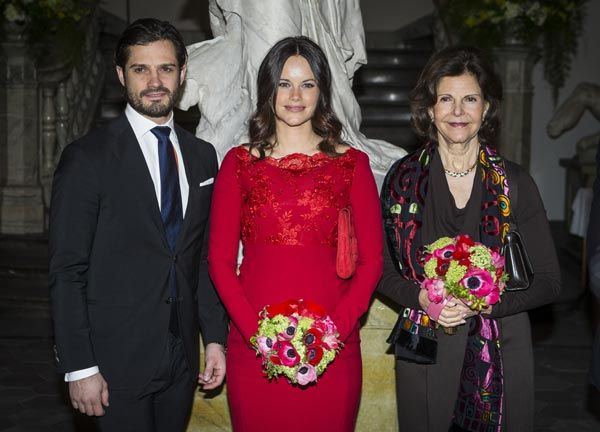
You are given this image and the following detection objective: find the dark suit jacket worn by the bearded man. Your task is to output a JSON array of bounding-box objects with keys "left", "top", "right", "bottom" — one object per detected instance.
[{"left": 49, "top": 114, "right": 227, "bottom": 389}]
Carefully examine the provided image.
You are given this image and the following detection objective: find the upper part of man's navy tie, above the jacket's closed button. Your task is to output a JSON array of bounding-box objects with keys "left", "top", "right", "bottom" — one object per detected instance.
[{"left": 151, "top": 126, "right": 183, "bottom": 252}]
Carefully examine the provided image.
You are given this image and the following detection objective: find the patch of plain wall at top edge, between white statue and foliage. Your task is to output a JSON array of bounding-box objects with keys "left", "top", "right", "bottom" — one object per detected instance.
[{"left": 360, "top": 0, "right": 433, "bottom": 32}]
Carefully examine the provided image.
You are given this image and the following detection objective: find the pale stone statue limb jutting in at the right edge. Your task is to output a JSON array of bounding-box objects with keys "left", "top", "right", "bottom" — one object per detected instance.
[{"left": 546, "top": 82, "right": 600, "bottom": 162}]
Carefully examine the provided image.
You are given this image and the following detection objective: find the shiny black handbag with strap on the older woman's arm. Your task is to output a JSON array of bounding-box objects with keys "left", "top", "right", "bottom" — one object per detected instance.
[{"left": 502, "top": 164, "right": 533, "bottom": 291}]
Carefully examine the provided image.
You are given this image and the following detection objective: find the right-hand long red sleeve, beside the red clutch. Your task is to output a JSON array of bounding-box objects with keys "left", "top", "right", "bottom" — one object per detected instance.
[{"left": 332, "top": 152, "right": 383, "bottom": 340}]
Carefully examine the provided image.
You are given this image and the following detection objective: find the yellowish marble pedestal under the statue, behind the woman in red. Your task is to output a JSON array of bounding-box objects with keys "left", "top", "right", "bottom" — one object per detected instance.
[{"left": 187, "top": 300, "right": 398, "bottom": 432}]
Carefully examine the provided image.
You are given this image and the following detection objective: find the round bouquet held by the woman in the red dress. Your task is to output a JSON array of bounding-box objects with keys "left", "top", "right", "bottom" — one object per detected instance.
[{"left": 250, "top": 300, "right": 343, "bottom": 386}]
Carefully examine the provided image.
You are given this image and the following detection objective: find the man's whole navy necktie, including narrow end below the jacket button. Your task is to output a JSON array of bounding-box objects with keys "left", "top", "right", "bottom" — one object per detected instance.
[{"left": 151, "top": 126, "right": 183, "bottom": 336}]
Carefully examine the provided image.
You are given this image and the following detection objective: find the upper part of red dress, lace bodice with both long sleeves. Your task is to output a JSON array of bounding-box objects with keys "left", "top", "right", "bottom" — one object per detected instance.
[{"left": 208, "top": 147, "right": 383, "bottom": 342}]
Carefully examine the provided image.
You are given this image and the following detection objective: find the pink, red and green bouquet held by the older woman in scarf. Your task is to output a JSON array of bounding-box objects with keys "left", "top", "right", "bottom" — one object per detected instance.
[{"left": 421, "top": 235, "right": 508, "bottom": 319}]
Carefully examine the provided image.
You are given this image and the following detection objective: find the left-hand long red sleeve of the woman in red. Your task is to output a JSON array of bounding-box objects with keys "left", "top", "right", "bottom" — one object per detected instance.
[{"left": 208, "top": 148, "right": 258, "bottom": 344}]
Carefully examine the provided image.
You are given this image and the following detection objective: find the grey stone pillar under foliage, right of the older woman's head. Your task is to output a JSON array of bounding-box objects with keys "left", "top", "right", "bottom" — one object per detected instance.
[{"left": 494, "top": 41, "right": 537, "bottom": 171}]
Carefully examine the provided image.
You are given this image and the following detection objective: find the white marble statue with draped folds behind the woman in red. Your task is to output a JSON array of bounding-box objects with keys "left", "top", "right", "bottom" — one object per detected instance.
[{"left": 179, "top": 0, "right": 406, "bottom": 182}]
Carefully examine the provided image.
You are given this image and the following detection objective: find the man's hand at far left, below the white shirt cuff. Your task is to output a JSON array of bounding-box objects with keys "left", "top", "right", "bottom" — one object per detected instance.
[{"left": 69, "top": 373, "right": 108, "bottom": 416}]
